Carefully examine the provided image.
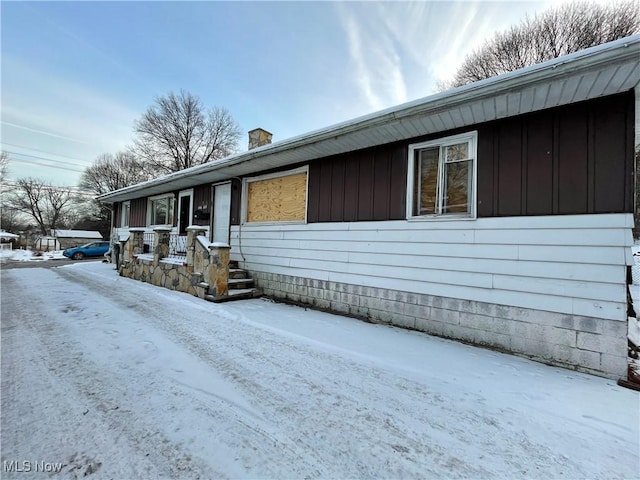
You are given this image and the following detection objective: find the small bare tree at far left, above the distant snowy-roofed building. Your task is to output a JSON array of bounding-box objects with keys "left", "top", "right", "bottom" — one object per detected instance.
[{"left": 7, "top": 177, "right": 73, "bottom": 235}]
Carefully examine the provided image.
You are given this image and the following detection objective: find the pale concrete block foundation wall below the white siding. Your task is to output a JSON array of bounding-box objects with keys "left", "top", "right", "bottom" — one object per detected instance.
[{"left": 252, "top": 272, "right": 627, "bottom": 378}]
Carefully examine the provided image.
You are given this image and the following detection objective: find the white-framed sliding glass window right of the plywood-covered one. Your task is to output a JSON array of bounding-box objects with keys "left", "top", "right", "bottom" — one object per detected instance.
[{"left": 407, "top": 132, "right": 477, "bottom": 218}]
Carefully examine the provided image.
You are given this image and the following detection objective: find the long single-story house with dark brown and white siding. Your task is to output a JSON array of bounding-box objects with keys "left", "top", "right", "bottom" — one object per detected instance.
[{"left": 100, "top": 36, "right": 640, "bottom": 377}]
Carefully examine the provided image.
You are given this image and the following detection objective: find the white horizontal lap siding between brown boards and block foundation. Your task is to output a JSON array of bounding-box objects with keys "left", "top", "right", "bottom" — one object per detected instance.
[{"left": 231, "top": 214, "right": 632, "bottom": 320}]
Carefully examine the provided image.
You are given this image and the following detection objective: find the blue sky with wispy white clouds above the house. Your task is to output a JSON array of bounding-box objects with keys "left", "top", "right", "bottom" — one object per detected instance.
[{"left": 0, "top": 1, "right": 572, "bottom": 185}]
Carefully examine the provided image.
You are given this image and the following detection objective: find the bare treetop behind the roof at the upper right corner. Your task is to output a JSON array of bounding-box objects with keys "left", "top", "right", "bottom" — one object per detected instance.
[{"left": 439, "top": 0, "right": 640, "bottom": 90}]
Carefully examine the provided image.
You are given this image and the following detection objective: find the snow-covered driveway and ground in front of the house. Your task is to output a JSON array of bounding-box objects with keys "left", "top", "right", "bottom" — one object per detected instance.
[{"left": 0, "top": 262, "right": 640, "bottom": 479}]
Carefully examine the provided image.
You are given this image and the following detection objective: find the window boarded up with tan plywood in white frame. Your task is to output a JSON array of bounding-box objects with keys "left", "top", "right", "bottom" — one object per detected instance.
[{"left": 246, "top": 171, "right": 307, "bottom": 222}]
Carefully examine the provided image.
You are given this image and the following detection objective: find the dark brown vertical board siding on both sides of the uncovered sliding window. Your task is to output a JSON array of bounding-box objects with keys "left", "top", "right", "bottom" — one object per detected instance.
[{"left": 304, "top": 92, "right": 634, "bottom": 223}]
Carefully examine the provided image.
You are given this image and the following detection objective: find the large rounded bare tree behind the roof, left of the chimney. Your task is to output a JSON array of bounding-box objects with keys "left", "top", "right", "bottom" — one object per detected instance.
[{"left": 135, "top": 90, "right": 240, "bottom": 173}]
